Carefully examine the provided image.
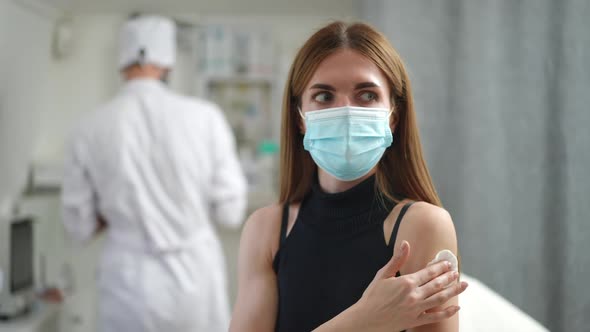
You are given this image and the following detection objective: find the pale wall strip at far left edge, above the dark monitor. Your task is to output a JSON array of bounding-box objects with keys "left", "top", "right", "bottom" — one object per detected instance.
[{"left": 0, "top": 0, "right": 53, "bottom": 212}]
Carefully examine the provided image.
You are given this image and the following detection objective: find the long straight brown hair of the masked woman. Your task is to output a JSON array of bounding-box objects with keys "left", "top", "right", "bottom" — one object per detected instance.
[{"left": 279, "top": 22, "right": 441, "bottom": 206}]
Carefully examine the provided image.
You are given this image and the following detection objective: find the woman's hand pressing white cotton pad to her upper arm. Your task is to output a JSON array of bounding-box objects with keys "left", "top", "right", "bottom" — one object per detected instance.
[{"left": 354, "top": 241, "right": 467, "bottom": 332}]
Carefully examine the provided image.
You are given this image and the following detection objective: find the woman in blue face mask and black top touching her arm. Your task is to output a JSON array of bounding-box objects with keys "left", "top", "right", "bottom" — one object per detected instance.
[{"left": 230, "top": 22, "right": 467, "bottom": 331}]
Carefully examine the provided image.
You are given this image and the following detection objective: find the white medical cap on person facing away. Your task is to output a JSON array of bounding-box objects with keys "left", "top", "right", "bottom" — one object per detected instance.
[{"left": 119, "top": 16, "right": 176, "bottom": 69}]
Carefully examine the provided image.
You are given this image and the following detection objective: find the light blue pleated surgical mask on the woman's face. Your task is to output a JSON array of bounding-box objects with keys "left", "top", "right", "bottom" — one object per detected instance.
[{"left": 299, "top": 106, "right": 393, "bottom": 181}]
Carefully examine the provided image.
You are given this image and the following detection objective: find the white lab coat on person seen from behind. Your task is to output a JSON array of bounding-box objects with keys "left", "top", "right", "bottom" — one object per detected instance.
[{"left": 62, "top": 80, "right": 246, "bottom": 332}]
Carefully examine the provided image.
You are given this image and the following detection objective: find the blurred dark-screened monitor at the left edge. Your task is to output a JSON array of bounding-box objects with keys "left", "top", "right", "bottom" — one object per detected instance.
[{"left": 0, "top": 216, "right": 35, "bottom": 319}]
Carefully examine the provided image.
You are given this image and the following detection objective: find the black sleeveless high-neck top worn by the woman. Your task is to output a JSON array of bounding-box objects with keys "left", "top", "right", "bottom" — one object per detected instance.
[{"left": 273, "top": 176, "right": 410, "bottom": 332}]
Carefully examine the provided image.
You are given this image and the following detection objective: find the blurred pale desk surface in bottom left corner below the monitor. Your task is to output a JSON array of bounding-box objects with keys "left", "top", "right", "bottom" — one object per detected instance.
[{"left": 0, "top": 302, "right": 59, "bottom": 332}]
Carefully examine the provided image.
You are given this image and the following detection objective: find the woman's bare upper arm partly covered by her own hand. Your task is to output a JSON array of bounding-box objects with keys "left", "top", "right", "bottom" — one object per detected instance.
[{"left": 395, "top": 202, "right": 459, "bottom": 332}]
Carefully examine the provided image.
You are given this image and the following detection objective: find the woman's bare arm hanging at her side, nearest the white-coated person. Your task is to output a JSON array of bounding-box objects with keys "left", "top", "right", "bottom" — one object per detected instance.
[{"left": 230, "top": 206, "right": 280, "bottom": 332}]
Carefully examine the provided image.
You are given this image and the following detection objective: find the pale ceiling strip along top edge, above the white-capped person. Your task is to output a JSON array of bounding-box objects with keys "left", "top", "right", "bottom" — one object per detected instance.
[{"left": 22, "top": 0, "right": 360, "bottom": 17}]
